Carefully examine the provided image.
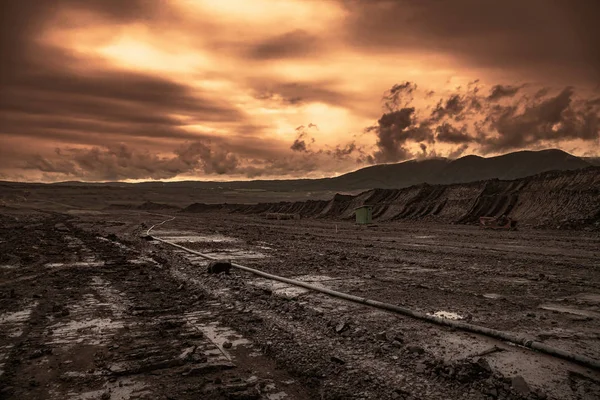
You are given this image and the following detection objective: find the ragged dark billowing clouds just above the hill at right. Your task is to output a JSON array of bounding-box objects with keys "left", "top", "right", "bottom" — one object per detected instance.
[{"left": 366, "top": 80, "right": 600, "bottom": 162}]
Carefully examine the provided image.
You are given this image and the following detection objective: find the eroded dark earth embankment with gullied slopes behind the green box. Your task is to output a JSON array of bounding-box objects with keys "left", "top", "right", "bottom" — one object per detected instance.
[{"left": 183, "top": 167, "right": 600, "bottom": 229}]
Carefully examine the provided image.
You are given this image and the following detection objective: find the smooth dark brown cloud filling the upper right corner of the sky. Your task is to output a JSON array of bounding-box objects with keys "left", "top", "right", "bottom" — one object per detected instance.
[{"left": 340, "top": 0, "right": 600, "bottom": 84}]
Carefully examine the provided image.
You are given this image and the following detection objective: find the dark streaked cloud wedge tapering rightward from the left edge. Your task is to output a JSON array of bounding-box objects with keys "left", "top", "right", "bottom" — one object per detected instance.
[{"left": 0, "top": 63, "right": 244, "bottom": 138}]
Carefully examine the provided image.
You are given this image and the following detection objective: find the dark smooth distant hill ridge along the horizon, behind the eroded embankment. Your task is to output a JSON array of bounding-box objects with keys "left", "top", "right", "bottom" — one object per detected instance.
[{"left": 12, "top": 149, "right": 599, "bottom": 192}]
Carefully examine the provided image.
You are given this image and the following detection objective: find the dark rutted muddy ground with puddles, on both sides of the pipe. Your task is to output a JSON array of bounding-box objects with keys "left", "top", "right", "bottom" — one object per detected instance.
[{"left": 0, "top": 207, "right": 600, "bottom": 400}]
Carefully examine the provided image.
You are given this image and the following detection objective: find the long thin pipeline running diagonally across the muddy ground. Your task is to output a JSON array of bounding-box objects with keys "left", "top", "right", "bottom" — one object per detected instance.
[{"left": 148, "top": 231, "right": 600, "bottom": 370}]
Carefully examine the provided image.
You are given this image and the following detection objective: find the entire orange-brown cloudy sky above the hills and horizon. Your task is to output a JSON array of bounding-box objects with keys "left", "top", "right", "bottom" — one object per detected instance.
[{"left": 0, "top": 0, "right": 600, "bottom": 182}]
